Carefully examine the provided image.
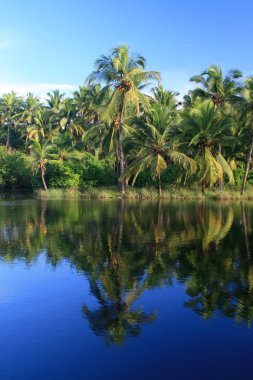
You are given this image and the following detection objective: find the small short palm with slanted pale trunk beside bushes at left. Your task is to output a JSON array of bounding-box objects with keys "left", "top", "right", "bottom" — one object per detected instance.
[{"left": 31, "top": 140, "right": 54, "bottom": 190}]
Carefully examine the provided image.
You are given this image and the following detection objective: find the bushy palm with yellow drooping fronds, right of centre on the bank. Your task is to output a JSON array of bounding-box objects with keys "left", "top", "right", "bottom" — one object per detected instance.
[{"left": 181, "top": 100, "right": 234, "bottom": 192}]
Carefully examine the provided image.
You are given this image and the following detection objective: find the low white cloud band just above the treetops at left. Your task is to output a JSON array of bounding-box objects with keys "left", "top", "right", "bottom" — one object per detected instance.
[{"left": 0, "top": 82, "right": 78, "bottom": 98}]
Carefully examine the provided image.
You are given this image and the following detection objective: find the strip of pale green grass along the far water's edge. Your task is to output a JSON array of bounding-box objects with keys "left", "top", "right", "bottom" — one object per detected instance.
[{"left": 35, "top": 187, "right": 253, "bottom": 200}]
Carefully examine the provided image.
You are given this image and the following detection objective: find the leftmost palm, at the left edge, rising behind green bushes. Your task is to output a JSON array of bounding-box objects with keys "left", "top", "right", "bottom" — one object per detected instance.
[{"left": 0, "top": 92, "right": 23, "bottom": 150}]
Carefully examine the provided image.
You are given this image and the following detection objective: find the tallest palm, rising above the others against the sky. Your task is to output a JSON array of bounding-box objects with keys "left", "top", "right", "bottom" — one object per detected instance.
[{"left": 88, "top": 45, "right": 160, "bottom": 191}]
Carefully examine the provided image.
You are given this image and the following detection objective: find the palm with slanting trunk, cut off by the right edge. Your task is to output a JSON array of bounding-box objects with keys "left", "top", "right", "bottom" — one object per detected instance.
[{"left": 241, "top": 77, "right": 253, "bottom": 194}]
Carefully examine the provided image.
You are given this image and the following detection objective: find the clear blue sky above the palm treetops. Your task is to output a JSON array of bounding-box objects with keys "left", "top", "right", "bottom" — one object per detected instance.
[{"left": 0, "top": 0, "right": 253, "bottom": 98}]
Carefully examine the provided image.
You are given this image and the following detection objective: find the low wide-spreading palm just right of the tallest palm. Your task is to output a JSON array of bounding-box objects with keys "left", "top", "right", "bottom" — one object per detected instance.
[{"left": 121, "top": 104, "right": 196, "bottom": 196}]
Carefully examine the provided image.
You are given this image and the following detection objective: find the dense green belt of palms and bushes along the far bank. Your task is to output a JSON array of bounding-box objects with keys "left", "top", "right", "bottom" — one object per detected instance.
[{"left": 0, "top": 45, "right": 253, "bottom": 195}]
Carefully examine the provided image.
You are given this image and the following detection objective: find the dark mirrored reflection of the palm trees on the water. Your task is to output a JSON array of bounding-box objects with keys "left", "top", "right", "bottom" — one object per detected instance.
[{"left": 0, "top": 200, "right": 253, "bottom": 344}]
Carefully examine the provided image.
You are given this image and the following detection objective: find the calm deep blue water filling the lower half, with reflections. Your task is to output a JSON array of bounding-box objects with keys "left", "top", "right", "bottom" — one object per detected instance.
[{"left": 0, "top": 199, "right": 253, "bottom": 380}]
